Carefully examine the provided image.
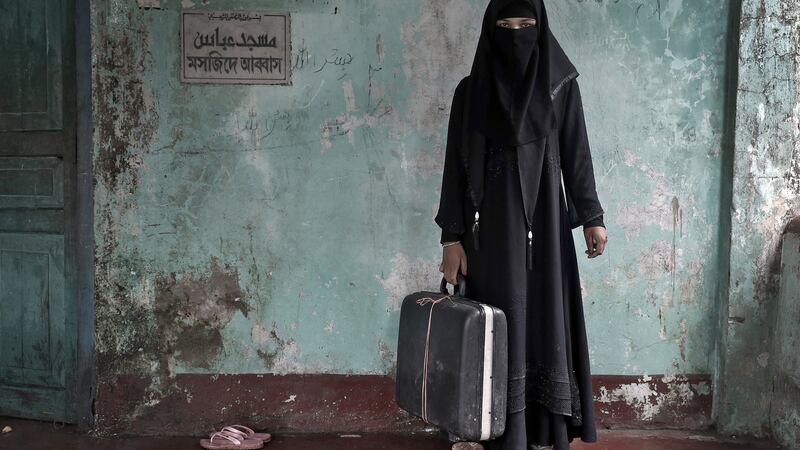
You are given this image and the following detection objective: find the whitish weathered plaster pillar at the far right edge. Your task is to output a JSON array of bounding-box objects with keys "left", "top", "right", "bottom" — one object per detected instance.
[{"left": 717, "top": 0, "right": 800, "bottom": 440}]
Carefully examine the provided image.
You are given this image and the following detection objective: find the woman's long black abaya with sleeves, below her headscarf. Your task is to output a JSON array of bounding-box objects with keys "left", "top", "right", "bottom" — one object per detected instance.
[{"left": 436, "top": 73, "right": 603, "bottom": 450}]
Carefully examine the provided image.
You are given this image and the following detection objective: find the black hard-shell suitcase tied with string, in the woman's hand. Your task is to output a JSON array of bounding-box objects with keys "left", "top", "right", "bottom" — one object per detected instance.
[{"left": 395, "top": 274, "right": 508, "bottom": 441}]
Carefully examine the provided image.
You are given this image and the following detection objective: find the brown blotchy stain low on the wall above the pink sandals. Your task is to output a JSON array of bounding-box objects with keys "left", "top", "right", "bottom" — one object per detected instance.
[{"left": 98, "top": 258, "right": 251, "bottom": 389}]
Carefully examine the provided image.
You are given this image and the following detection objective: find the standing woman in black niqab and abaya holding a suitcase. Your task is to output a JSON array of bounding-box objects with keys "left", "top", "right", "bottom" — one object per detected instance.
[{"left": 436, "top": 0, "right": 607, "bottom": 450}]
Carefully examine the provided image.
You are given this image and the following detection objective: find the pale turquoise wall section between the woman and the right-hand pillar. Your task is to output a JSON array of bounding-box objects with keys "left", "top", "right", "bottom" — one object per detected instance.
[{"left": 550, "top": 1, "right": 727, "bottom": 380}]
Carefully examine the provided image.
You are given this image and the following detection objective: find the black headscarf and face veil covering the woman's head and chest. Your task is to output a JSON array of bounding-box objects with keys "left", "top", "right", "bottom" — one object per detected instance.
[{"left": 467, "top": 0, "right": 560, "bottom": 145}]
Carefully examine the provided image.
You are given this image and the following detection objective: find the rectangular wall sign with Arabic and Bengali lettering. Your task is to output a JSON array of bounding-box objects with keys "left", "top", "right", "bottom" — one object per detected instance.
[{"left": 181, "top": 10, "right": 292, "bottom": 85}]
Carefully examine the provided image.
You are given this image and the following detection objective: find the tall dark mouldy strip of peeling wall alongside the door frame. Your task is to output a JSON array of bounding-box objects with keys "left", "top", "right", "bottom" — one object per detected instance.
[{"left": 92, "top": 4, "right": 159, "bottom": 379}]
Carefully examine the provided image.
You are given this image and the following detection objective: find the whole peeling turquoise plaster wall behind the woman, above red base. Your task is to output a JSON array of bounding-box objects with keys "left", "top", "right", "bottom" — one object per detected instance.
[{"left": 92, "top": 0, "right": 732, "bottom": 432}]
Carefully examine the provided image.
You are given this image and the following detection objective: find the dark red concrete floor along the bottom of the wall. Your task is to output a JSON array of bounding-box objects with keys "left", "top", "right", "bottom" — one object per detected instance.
[{"left": 0, "top": 417, "right": 781, "bottom": 450}]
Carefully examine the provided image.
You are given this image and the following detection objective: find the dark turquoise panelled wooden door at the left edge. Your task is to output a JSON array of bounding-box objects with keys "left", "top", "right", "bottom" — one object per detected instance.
[{"left": 0, "top": 0, "right": 77, "bottom": 422}]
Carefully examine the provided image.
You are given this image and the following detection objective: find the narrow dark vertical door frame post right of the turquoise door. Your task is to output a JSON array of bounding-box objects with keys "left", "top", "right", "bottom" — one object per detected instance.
[{"left": 73, "top": 0, "right": 97, "bottom": 430}]
